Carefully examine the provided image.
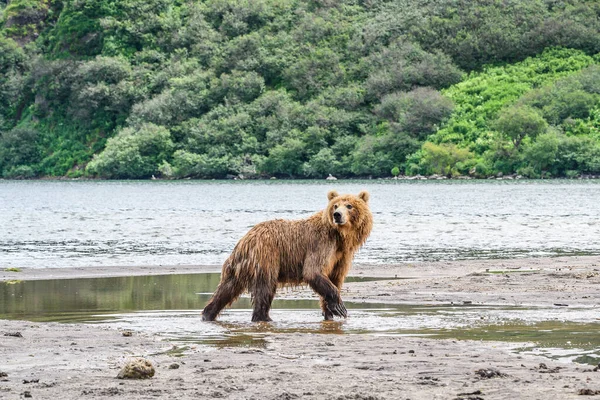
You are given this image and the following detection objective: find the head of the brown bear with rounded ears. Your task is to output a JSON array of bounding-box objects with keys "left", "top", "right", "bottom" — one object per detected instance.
[{"left": 323, "top": 190, "right": 373, "bottom": 244}]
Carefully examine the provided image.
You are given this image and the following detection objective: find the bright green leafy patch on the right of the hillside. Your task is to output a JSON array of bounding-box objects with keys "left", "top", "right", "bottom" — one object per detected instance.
[{"left": 410, "top": 50, "right": 600, "bottom": 178}]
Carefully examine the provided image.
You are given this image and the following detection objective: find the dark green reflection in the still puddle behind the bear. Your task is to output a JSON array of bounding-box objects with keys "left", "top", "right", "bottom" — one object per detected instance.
[{"left": 0, "top": 273, "right": 390, "bottom": 322}]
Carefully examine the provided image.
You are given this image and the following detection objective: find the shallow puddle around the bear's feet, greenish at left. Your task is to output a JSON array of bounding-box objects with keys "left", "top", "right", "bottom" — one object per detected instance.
[{"left": 0, "top": 274, "right": 600, "bottom": 364}]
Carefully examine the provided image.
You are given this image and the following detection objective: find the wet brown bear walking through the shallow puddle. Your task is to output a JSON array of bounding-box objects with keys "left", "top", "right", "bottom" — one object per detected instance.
[{"left": 202, "top": 191, "right": 373, "bottom": 321}]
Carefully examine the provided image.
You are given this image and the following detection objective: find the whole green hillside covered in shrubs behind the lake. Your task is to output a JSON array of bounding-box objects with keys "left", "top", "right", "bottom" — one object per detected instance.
[{"left": 0, "top": 0, "right": 600, "bottom": 178}]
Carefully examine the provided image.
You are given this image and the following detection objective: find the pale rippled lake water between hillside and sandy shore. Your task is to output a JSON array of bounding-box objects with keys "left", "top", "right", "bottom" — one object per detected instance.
[{"left": 0, "top": 180, "right": 600, "bottom": 268}]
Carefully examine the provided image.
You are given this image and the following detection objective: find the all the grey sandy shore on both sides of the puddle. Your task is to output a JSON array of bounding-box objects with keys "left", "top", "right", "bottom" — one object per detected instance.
[{"left": 0, "top": 257, "right": 600, "bottom": 400}]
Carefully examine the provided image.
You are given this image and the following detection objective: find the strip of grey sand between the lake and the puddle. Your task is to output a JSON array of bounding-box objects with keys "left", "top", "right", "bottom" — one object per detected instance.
[{"left": 0, "top": 256, "right": 600, "bottom": 307}]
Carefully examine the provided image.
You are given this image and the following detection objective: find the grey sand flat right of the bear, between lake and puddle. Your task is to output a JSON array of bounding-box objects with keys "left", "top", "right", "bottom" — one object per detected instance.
[{"left": 344, "top": 256, "right": 600, "bottom": 308}]
